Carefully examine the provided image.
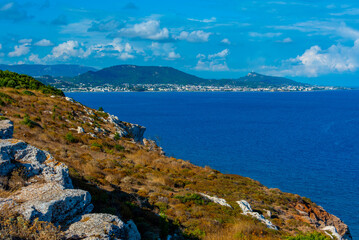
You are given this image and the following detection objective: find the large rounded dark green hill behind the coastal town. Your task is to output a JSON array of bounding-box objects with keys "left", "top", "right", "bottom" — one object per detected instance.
[{"left": 72, "top": 65, "right": 207, "bottom": 85}]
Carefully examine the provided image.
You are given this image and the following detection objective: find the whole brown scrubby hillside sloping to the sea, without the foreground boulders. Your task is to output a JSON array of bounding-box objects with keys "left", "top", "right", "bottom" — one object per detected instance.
[{"left": 0, "top": 71, "right": 350, "bottom": 240}]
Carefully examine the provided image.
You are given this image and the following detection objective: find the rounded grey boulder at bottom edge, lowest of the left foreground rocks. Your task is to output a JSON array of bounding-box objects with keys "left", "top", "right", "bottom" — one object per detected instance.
[{"left": 66, "top": 213, "right": 141, "bottom": 240}]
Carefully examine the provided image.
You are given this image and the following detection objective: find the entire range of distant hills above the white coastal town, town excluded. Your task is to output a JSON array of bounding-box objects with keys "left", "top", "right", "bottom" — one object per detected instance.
[{"left": 0, "top": 64, "right": 308, "bottom": 88}]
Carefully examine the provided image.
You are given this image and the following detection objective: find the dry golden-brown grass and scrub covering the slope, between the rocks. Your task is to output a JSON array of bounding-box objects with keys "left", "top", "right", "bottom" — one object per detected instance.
[{"left": 0, "top": 89, "right": 330, "bottom": 239}]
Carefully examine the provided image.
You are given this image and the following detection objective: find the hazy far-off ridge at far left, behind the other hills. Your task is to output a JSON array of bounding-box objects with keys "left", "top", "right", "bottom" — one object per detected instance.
[{"left": 0, "top": 64, "right": 97, "bottom": 77}]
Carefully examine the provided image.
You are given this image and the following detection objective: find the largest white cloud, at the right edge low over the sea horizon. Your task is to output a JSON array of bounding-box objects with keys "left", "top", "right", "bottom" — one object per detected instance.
[{"left": 270, "top": 40, "right": 359, "bottom": 77}]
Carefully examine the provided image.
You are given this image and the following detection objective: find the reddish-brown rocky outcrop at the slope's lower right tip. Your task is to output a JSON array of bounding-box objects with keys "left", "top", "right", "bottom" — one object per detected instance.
[{"left": 294, "top": 200, "right": 352, "bottom": 240}]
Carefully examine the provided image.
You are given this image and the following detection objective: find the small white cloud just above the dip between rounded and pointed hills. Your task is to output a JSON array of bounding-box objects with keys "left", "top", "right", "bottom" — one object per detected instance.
[{"left": 194, "top": 49, "right": 229, "bottom": 71}]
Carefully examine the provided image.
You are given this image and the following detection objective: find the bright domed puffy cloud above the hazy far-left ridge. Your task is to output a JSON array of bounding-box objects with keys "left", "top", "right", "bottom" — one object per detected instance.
[{"left": 46, "top": 40, "right": 91, "bottom": 60}]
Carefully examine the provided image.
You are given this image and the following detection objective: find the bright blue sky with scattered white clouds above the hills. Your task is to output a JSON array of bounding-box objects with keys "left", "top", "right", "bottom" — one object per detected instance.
[{"left": 0, "top": 0, "right": 359, "bottom": 86}]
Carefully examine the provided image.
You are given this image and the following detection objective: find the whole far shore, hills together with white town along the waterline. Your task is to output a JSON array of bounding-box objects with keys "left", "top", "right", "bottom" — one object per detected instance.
[{"left": 0, "top": 64, "right": 349, "bottom": 92}]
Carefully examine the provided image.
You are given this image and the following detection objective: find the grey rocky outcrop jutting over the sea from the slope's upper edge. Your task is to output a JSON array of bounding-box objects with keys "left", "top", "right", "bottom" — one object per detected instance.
[{"left": 106, "top": 114, "right": 146, "bottom": 143}]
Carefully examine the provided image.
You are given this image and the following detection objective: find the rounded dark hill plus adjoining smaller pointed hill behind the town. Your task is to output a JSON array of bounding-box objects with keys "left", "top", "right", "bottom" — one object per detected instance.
[{"left": 68, "top": 65, "right": 305, "bottom": 87}]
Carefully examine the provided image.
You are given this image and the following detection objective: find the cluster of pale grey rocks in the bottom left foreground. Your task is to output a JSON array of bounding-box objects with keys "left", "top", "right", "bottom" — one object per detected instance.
[{"left": 0, "top": 121, "right": 141, "bottom": 240}]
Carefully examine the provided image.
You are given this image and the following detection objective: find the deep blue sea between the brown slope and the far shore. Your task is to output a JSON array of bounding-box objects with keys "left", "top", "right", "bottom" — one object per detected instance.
[{"left": 66, "top": 91, "right": 359, "bottom": 239}]
